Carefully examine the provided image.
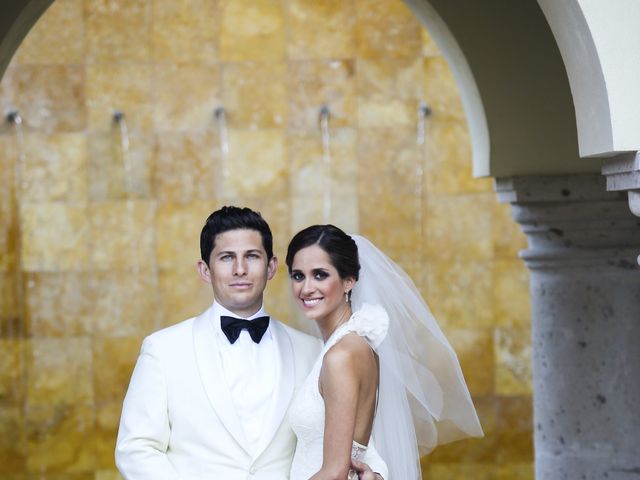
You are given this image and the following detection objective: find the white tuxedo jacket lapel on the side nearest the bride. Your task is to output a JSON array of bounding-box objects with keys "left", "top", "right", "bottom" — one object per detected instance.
[{"left": 254, "top": 319, "right": 295, "bottom": 458}]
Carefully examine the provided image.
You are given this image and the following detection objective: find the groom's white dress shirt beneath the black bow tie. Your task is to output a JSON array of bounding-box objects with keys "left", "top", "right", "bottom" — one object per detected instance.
[{"left": 213, "top": 302, "right": 280, "bottom": 452}]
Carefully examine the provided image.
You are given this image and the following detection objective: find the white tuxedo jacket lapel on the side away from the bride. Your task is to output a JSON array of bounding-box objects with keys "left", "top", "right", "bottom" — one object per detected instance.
[{"left": 193, "top": 308, "right": 249, "bottom": 453}]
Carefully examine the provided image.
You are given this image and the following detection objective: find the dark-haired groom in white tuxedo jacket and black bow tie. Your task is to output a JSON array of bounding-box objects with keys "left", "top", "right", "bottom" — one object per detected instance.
[{"left": 116, "top": 207, "right": 384, "bottom": 480}]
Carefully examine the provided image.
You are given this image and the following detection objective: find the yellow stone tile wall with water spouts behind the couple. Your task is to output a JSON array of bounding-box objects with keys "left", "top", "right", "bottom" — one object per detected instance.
[{"left": 0, "top": 0, "right": 533, "bottom": 480}]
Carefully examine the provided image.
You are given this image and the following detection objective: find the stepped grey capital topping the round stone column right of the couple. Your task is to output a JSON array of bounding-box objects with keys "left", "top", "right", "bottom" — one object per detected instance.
[{"left": 496, "top": 174, "right": 640, "bottom": 269}]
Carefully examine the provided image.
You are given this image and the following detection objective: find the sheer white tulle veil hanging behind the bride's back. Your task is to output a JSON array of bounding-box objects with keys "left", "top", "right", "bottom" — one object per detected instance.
[{"left": 351, "top": 235, "right": 483, "bottom": 480}]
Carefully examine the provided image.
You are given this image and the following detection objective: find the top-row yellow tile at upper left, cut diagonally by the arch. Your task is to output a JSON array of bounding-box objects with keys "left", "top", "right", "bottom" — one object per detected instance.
[{"left": 13, "top": 0, "right": 84, "bottom": 65}]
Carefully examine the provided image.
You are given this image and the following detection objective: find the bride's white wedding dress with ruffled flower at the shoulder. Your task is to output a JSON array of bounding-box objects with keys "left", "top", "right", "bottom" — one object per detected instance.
[{"left": 289, "top": 304, "right": 389, "bottom": 480}]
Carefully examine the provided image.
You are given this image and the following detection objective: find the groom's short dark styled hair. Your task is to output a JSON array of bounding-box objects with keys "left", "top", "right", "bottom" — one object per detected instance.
[{"left": 200, "top": 206, "right": 273, "bottom": 265}]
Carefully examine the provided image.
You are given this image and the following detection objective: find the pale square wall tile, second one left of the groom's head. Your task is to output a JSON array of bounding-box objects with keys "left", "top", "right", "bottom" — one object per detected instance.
[{"left": 88, "top": 270, "right": 162, "bottom": 338}]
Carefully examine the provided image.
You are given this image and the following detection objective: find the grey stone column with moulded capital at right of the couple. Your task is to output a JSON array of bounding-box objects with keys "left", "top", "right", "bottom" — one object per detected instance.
[{"left": 496, "top": 175, "right": 640, "bottom": 480}]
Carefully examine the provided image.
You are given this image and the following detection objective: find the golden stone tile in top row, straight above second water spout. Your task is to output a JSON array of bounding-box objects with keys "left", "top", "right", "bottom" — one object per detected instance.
[{"left": 85, "top": 0, "right": 154, "bottom": 63}]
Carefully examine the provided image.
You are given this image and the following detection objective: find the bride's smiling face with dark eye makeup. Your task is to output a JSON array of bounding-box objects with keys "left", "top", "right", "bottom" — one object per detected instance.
[{"left": 291, "top": 245, "right": 354, "bottom": 321}]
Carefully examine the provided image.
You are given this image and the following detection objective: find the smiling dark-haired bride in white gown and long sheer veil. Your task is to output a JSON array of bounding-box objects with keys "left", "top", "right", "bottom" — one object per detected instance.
[{"left": 286, "top": 225, "right": 482, "bottom": 480}]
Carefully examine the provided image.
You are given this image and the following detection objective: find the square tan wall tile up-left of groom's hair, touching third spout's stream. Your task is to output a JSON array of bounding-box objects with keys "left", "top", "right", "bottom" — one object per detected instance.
[{"left": 153, "top": 131, "right": 219, "bottom": 203}]
